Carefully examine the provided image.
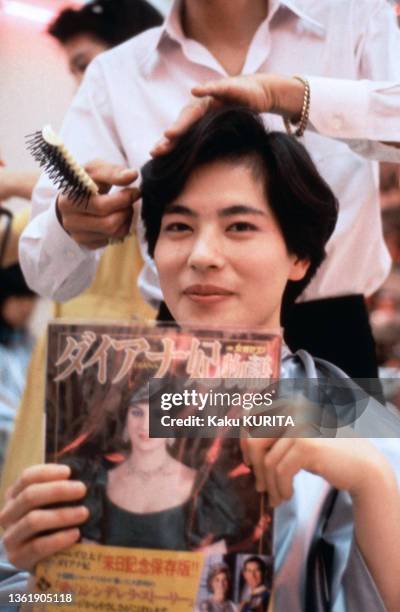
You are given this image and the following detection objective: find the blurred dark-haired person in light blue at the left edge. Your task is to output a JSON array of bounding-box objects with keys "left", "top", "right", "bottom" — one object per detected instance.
[{"left": 0, "top": 264, "right": 36, "bottom": 466}]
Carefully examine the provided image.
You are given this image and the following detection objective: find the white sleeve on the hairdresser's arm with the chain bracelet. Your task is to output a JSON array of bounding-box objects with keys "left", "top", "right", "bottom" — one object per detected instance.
[{"left": 307, "top": 0, "right": 400, "bottom": 162}]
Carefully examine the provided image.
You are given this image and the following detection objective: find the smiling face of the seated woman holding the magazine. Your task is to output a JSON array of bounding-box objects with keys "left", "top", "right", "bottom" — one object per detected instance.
[{"left": 154, "top": 161, "right": 308, "bottom": 329}]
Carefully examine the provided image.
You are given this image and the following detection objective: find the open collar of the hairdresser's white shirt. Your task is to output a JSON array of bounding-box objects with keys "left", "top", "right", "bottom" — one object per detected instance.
[{"left": 153, "top": 0, "right": 326, "bottom": 56}]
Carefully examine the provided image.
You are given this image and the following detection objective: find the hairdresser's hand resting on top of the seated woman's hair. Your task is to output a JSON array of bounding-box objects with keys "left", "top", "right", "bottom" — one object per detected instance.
[{"left": 151, "top": 74, "right": 304, "bottom": 156}]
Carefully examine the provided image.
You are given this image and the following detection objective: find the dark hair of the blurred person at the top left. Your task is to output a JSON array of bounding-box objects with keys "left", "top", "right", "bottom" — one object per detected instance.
[{"left": 47, "top": 0, "right": 163, "bottom": 47}]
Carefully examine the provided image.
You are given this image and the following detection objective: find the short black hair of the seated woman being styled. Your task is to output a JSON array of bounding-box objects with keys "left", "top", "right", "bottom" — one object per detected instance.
[{"left": 142, "top": 106, "right": 338, "bottom": 304}]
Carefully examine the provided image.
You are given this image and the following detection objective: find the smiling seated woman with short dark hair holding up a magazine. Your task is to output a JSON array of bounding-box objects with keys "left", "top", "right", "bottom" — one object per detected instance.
[{"left": 0, "top": 108, "right": 400, "bottom": 612}]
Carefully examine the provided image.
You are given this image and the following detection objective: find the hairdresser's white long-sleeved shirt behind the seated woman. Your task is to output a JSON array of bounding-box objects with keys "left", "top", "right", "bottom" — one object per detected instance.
[{"left": 20, "top": 0, "right": 400, "bottom": 304}]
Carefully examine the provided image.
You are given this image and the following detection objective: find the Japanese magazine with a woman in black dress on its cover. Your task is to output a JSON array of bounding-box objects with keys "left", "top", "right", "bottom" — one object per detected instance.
[{"left": 36, "top": 322, "right": 281, "bottom": 612}]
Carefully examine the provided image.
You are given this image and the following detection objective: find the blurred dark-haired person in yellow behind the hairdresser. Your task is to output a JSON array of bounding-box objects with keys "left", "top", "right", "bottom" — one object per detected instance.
[{"left": 0, "top": 0, "right": 162, "bottom": 503}]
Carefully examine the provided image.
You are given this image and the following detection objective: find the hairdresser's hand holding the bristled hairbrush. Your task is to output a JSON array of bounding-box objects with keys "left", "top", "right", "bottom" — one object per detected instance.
[{"left": 57, "top": 160, "right": 140, "bottom": 249}]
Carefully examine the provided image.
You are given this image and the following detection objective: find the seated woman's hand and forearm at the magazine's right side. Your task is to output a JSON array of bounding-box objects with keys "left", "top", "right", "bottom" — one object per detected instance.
[{"left": 241, "top": 437, "right": 391, "bottom": 506}]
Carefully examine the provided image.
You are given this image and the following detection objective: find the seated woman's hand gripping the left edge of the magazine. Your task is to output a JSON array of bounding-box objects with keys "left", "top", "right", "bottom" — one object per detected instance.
[{"left": 0, "top": 464, "right": 89, "bottom": 571}]
